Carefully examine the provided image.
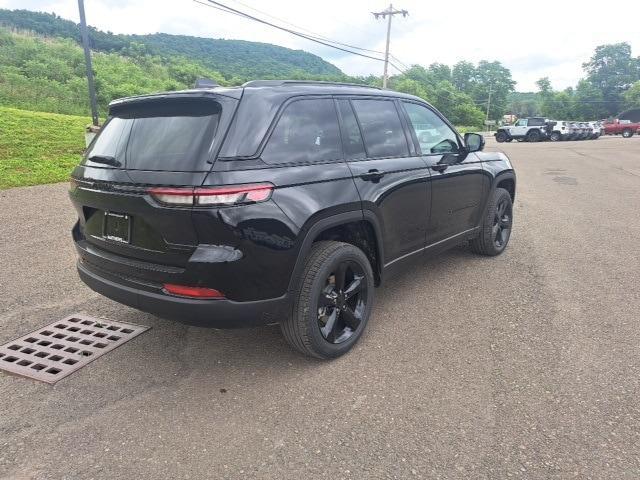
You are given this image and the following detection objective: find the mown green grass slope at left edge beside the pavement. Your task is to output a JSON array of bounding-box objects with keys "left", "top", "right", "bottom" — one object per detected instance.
[{"left": 0, "top": 107, "right": 91, "bottom": 189}]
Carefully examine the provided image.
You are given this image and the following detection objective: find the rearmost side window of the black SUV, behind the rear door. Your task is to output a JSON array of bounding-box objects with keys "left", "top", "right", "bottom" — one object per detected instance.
[{"left": 261, "top": 98, "right": 342, "bottom": 164}]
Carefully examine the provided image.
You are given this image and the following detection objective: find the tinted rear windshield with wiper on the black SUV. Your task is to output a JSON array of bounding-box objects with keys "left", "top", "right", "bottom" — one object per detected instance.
[{"left": 84, "top": 98, "right": 222, "bottom": 171}]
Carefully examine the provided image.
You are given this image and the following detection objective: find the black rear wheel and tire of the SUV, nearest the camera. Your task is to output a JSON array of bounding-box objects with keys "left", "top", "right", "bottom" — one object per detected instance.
[{"left": 280, "top": 241, "right": 375, "bottom": 360}]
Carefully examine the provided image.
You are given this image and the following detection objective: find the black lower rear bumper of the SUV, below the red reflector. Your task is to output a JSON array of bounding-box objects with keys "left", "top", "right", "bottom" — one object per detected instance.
[{"left": 78, "top": 262, "right": 288, "bottom": 328}]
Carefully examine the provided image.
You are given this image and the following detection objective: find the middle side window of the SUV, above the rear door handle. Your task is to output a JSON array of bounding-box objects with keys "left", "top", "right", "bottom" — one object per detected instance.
[{"left": 352, "top": 100, "right": 409, "bottom": 158}]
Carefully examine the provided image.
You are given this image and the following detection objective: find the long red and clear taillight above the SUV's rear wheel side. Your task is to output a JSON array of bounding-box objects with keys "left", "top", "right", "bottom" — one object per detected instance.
[{"left": 148, "top": 183, "right": 273, "bottom": 207}]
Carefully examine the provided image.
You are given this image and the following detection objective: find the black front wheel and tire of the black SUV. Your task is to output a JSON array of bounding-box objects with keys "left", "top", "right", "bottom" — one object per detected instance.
[{"left": 470, "top": 188, "right": 513, "bottom": 256}]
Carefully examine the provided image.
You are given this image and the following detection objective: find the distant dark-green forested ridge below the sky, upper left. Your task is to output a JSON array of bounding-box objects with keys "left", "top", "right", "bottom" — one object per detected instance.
[{"left": 0, "top": 9, "right": 342, "bottom": 79}]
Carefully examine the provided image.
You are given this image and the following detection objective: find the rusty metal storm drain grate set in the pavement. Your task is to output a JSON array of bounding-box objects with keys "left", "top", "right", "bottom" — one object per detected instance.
[{"left": 0, "top": 315, "right": 149, "bottom": 384}]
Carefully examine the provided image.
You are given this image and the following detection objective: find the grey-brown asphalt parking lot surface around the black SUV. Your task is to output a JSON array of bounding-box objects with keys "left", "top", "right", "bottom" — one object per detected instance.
[{"left": 0, "top": 137, "right": 640, "bottom": 479}]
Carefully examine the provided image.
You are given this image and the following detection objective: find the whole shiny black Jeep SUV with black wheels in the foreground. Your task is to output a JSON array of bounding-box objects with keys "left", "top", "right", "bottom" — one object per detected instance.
[{"left": 70, "top": 81, "right": 516, "bottom": 358}]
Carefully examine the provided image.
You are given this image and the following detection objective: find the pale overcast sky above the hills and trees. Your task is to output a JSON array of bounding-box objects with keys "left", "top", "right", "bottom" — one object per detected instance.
[{"left": 0, "top": 0, "right": 640, "bottom": 91}]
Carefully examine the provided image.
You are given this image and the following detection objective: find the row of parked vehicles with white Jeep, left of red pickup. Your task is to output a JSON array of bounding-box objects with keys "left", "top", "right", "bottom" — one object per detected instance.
[{"left": 495, "top": 117, "right": 605, "bottom": 143}]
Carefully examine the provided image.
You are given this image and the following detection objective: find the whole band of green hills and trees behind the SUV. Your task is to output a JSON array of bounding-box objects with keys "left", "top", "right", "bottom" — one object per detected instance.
[{"left": 0, "top": 9, "right": 640, "bottom": 128}]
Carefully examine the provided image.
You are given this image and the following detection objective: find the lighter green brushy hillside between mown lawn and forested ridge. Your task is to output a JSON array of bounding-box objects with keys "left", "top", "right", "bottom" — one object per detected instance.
[{"left": 0, "top": 27, "right": 235, "bottom": 115}]
